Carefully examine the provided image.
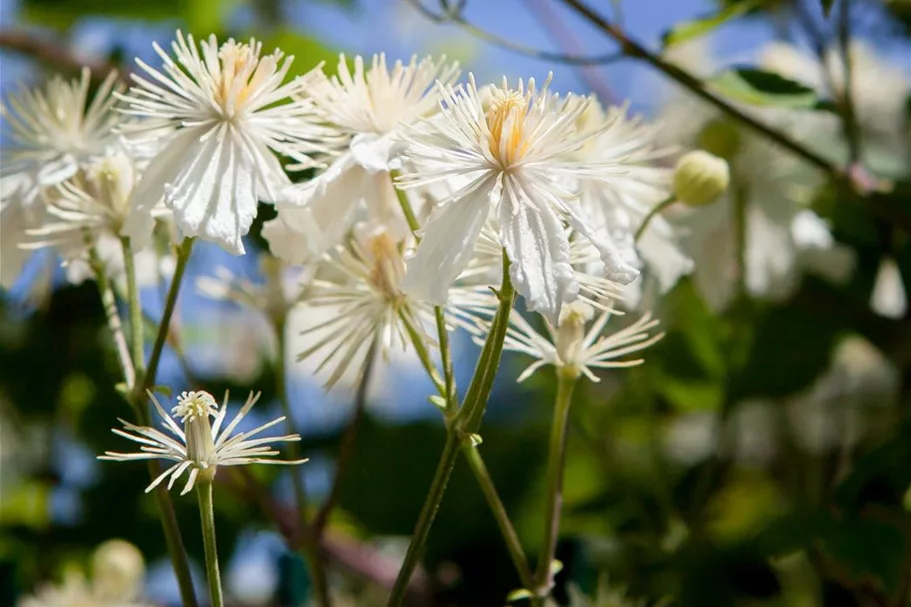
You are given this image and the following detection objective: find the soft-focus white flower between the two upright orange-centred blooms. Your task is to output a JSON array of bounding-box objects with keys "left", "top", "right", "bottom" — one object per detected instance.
[{"left": 274, "top": 54, "right": 459, "bottom": 263}]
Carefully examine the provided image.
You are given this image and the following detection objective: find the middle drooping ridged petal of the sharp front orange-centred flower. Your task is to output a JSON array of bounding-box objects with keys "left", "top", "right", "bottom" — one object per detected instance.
[{"left": 499, "top": 176, "right": 579, "bottom": 325}]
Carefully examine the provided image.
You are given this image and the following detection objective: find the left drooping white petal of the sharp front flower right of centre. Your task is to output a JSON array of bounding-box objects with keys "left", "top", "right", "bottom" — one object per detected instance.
[{"left": 401, "top": 182, "right": 491, "bottom": 305}]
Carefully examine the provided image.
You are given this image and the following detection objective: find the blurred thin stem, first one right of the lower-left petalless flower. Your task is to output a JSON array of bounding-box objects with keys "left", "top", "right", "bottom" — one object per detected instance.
[{"left": 272, "top": 312, "right": 332, "bottom": 607}]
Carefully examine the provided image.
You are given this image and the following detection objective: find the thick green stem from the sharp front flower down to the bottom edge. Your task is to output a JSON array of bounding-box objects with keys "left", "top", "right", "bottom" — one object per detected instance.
[{"left": 386, "top": 252, "right": 515, "bottom": 607}]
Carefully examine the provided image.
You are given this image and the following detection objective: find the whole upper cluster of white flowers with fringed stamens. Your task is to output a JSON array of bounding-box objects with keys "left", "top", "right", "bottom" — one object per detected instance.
[{"left": 2, "top": 32, "right": 691, "bottom": 394}]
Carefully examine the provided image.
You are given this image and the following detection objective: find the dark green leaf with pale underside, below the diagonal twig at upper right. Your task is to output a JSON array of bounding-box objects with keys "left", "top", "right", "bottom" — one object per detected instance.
[{"left": 707, "top": 67, "right": 819, "bottom": 108}]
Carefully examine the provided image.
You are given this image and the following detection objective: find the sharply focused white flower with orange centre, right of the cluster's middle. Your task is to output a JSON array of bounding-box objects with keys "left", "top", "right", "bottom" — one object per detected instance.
[{"left": 401, "top": 75, "right": 638, "bottom": 322}]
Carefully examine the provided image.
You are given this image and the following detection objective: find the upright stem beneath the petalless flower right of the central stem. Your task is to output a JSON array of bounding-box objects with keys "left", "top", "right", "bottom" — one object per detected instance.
[{"left": 532, "top": 373, "right": 576, "bottom": 607}]
